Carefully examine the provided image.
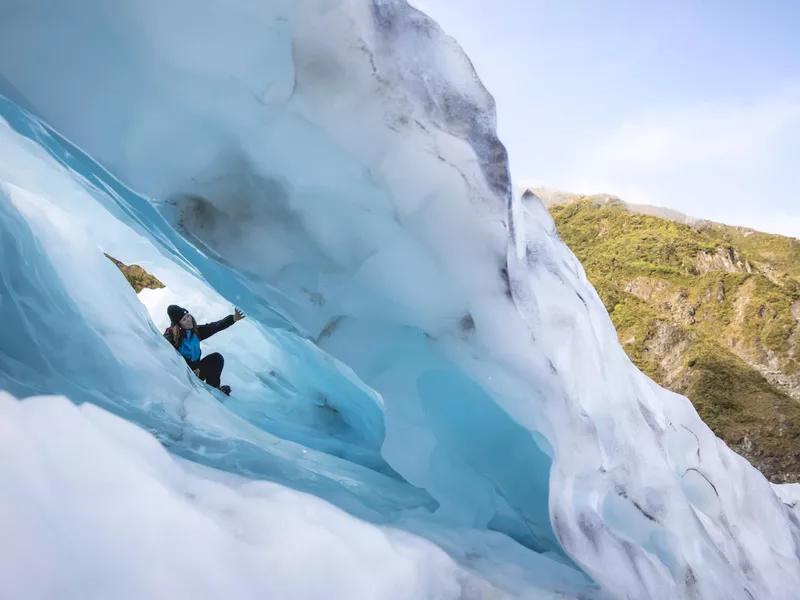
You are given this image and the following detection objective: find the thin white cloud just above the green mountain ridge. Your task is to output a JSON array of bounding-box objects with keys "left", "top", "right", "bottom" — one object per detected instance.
[{"left": 549, "top": 85, "right": 800, "bottom": 237}]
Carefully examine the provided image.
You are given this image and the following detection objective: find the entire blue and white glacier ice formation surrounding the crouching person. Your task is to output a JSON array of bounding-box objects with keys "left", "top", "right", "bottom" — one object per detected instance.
[{"left": 0, "top": 0, "right": 800, "bottom": 600}]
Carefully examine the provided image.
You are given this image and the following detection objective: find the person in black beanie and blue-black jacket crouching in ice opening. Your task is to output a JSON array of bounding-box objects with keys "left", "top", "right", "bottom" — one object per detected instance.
[{"left": 164, "top": 304, "right": 244, "bottom": 396}]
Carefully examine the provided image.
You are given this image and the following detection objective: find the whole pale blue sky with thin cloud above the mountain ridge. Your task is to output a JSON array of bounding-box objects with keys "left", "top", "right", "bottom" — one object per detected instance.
[{"left": 412, "top": 0, "right": 800, "bottom": 237}]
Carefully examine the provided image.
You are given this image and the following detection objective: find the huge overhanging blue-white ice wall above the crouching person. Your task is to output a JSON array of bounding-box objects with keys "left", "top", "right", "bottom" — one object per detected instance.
[{"left": 0, "top": 0, "right": 800, "bottom": 599}]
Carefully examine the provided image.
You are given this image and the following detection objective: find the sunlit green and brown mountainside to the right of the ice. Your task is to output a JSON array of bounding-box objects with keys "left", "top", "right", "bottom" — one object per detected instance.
[{"left": 536, "top": 195, "right": 800, "bottom": 482}]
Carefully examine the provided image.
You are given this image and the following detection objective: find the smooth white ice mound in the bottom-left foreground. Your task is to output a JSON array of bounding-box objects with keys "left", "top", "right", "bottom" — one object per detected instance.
[{"left": 0, "top": 392, "right": 497, "bottom": 600}]
